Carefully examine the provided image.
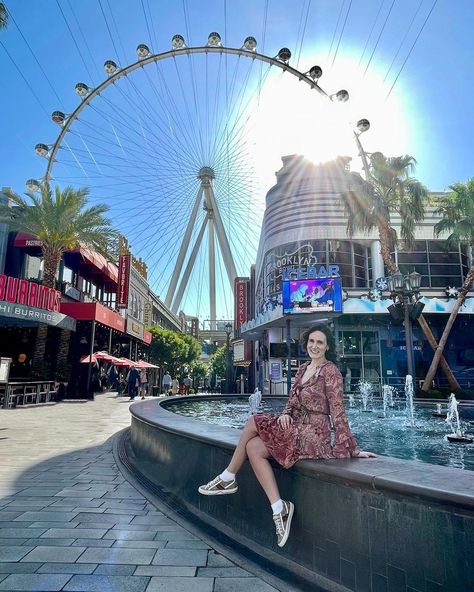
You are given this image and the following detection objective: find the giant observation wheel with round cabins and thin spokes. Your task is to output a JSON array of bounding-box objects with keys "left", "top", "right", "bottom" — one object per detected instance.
[{"left": 27, "top": 32, "right": 369, "bottom": 328}]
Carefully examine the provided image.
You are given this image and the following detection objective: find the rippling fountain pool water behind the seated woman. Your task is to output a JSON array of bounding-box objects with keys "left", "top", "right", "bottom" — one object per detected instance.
[{"left": 166, "top": 397, "right": 474, "bottom": 471}]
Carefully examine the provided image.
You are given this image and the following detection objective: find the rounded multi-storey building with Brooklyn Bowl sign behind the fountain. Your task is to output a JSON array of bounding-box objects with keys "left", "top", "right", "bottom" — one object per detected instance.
[{"left": 242, "top": 155, "right": 474, "bottom": 392}]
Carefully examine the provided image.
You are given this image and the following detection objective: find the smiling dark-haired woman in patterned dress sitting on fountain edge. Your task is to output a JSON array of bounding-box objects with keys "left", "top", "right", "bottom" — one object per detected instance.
[{"left": 198, "top": 325, "right": 376, "bottom": 547}]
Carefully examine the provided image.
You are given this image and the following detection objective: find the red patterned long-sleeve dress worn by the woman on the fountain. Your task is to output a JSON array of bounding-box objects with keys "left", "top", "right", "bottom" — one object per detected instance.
[{"left": 254, "top": 362, "right": 357, "bottom": 469}]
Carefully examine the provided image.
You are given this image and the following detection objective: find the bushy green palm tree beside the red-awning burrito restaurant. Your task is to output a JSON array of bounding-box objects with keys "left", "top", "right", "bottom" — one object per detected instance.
[{"left": 0, "top": 184, "right": 116, "bottom": 367}]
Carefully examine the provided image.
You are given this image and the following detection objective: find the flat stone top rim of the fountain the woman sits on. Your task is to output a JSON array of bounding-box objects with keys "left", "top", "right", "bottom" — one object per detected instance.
[{"left": 130, "top": 395, "right": 474, "bottom": 511}]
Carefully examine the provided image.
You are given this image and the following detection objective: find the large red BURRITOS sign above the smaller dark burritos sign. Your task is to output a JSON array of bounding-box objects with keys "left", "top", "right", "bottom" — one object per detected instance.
[{"left": 0, "top": 274, "right": 61, "bottom": 312}]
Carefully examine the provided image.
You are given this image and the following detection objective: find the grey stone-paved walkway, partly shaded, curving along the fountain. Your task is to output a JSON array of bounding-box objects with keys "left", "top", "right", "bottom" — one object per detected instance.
[{"left": 0, "top": 393, "right": 277, "bottom": 592}]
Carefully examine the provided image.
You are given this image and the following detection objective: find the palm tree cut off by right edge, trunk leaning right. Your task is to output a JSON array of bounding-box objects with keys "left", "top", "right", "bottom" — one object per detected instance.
[{"left": 422, "top": 179, "right": 474, "bottom": 391}]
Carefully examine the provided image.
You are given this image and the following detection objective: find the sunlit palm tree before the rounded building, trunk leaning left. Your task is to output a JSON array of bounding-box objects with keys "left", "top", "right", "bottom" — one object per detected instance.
[{"left": 341, "top": 152, "right": 459, "bottom": 388}]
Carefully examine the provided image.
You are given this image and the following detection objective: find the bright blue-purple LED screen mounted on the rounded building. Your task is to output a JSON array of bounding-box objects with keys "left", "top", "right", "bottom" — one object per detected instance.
[{"left": 283, "top": 277, "right": 342, "bottom": 314}]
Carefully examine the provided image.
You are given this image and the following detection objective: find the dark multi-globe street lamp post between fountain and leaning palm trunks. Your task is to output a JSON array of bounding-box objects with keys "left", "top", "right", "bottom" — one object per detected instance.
[{"left": 388, "top": 270, "right": 424, "bottom": 378}]
